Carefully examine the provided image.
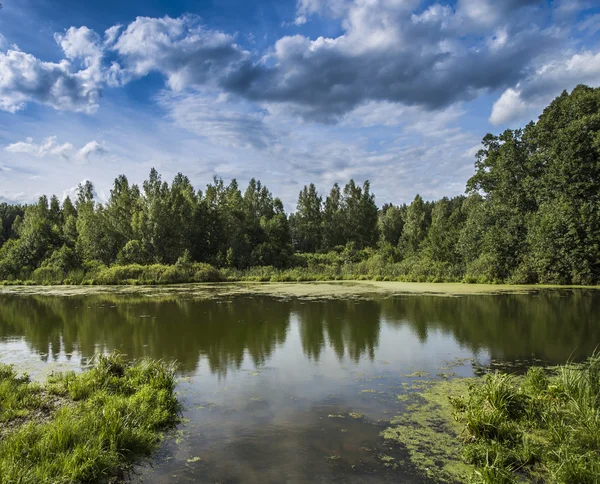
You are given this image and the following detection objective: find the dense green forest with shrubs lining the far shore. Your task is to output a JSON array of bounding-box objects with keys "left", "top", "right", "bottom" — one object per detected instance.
[{"left": 0, "top": 86, "right": 600, "bottom": 284}]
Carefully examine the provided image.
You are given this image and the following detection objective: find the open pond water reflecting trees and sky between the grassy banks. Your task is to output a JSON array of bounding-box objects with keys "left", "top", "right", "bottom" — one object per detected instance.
[{"left": 0, "top": 290, "right": 600, "bottom": 483}]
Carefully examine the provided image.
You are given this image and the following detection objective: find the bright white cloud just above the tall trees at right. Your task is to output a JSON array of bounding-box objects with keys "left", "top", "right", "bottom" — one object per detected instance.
[{"left": 490, "top": 51, "right": 600, "bottom": 124}]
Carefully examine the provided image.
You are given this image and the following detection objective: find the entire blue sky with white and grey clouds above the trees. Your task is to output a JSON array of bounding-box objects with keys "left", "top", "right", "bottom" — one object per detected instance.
[{"left": 0, "top": 0, "right": 600, "bottom": 211}]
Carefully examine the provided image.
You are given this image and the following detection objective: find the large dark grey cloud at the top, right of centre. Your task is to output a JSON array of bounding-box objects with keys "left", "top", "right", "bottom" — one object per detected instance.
[{"left": 223, "top": 0, "right": 558, "bottom": 122}]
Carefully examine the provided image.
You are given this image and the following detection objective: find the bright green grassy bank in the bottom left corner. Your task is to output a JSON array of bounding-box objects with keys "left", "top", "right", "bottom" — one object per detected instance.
[{"left": 0, "top": 355, "right": 179, "bottom": 483}]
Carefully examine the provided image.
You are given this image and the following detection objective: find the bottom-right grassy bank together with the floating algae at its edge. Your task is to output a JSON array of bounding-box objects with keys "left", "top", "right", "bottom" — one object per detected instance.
[{"left": 383, "top": 356, "right": 600, "bottom": 484}]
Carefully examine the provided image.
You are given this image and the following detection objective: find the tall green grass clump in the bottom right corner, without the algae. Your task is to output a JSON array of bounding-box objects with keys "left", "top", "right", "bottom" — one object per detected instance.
[{"left": 451, "top": 354, "right": 600, "bottom": 484}]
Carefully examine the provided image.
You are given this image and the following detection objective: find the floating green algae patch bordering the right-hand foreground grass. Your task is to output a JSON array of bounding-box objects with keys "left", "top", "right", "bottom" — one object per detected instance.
[{"left": 382, "top": 378, "right": 475, "bottom": 483}]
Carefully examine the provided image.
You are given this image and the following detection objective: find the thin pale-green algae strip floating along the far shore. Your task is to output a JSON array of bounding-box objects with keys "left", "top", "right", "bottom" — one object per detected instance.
[{"left": 0, "top": 281, "right": 600, "bottom": 298}]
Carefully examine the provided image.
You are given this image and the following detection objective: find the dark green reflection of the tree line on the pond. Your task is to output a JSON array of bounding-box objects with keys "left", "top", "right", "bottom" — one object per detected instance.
[{"left": 0, "top": 290, "right": 600, "bottom": 376}]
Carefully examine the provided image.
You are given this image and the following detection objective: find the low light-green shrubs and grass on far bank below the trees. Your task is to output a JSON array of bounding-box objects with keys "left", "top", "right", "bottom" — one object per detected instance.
[{"left": 0, "top": 250, "right": 523, "bottom": 285}]
